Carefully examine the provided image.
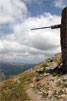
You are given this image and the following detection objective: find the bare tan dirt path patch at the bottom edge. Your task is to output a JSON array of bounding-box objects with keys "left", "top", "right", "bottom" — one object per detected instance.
[{"left": 27, "top": 88, "right": 45, "bottom": 101}]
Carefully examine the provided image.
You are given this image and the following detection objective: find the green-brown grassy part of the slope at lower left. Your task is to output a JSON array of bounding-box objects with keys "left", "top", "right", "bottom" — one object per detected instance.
[{"left": 0, "top": 73, "right": 36, "bottom": 101}]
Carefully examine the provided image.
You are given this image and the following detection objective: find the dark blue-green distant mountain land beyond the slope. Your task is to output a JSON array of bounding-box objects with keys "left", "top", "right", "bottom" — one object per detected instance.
[{"left": 0, "top": 62, "right": 34, "bottom": 78}]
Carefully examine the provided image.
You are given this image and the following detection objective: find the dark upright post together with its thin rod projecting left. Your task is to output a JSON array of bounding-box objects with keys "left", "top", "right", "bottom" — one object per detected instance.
[{"left": 31, "top": 7, "right": 67, "bottom": 73}]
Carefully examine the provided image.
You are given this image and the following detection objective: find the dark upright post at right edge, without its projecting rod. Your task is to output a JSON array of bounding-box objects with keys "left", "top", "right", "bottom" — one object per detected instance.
[{"left": 60, "top": 7, "right": 67, "bottom": 73}]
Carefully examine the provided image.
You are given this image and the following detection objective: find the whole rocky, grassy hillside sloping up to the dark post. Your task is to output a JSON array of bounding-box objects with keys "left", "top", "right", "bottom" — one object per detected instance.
[{"left": 0, "top": 53, "right": 67, "bottom": 101}]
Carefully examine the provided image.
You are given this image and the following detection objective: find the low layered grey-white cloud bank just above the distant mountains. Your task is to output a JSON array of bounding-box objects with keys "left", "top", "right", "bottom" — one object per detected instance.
[{"left": 0, "top": 34, "right": 50, "bottom": 62}]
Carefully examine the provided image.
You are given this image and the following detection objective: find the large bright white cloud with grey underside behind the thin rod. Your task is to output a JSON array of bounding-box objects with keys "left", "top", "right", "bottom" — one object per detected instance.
[{"left": 14, "top": 13, "right": 61, "bottom": 51}]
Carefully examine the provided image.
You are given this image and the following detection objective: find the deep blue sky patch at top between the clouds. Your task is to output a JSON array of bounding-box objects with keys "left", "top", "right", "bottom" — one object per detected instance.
[{"left": 27, "top": 0, "right": 62, "bottom": 16}]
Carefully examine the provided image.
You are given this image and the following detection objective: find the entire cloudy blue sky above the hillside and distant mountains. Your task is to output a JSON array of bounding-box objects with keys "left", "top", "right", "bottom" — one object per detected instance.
[{"left": 0, "top": 0, "right": 67, "bottom": 63}]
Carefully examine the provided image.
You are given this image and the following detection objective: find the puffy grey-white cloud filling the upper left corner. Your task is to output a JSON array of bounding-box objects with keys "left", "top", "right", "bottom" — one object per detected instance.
[{"left": 0, "top": 0, "right": 27, "bottom": 24}]
